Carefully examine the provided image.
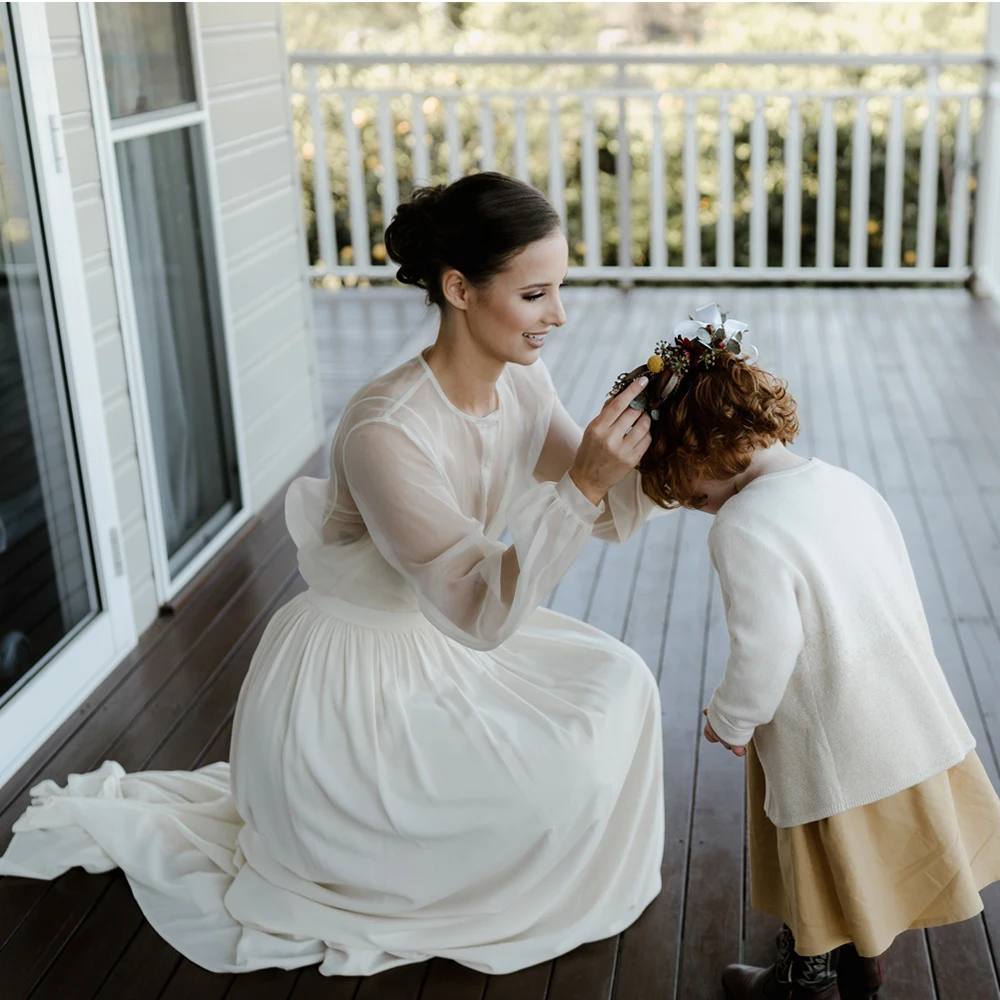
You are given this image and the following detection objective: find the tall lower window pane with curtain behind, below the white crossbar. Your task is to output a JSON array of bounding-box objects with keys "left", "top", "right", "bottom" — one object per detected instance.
[{"left": 115, "top": 127, "right": 239, "bottom": 574}]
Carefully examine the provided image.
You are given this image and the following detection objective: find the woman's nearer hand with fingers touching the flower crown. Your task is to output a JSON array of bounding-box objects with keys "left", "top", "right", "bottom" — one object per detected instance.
[{"left": 569, "top": 377, "right": 652, "bottom": 507}]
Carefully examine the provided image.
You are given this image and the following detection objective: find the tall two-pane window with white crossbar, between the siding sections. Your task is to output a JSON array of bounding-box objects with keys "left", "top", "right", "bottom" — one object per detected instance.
[{"left": 94, "top": 3, "right": 242, "bottom": 596}]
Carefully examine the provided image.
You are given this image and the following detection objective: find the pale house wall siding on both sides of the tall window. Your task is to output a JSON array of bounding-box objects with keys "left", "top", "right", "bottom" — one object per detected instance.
[{"left": 46, "top": 3, "right": 323, "bottom": 630}]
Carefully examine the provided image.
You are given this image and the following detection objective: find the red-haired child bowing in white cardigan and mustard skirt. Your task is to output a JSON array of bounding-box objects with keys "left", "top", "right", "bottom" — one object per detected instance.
[{"left": 613, "top": 305, "right": 1000, "bottom": 1000}]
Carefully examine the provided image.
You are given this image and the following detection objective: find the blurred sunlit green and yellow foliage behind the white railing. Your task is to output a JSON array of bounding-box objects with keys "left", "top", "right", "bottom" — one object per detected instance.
[{"left": 286, "top": 3, "right": 985, "bottom": 278}]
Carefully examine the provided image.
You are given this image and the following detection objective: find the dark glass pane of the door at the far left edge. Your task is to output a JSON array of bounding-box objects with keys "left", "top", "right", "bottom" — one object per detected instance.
[{"left": 0, "top": 17, "right": 99, "bottom": 702}]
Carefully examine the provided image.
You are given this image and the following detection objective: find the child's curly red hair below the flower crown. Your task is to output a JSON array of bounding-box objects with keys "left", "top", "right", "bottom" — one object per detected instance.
[{"left": 639, "top": 352, "right": 799, "bottom": 508}]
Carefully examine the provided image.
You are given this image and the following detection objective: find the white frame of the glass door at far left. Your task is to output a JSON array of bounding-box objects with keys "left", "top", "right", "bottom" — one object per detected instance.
[{"left": 0, "top": 3, "right": 137, "bottom": 786}]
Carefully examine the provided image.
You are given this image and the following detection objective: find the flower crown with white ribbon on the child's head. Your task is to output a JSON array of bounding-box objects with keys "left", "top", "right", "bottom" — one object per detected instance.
[{"left": 608, "top": 302, "right": 758, "bottom": 420}]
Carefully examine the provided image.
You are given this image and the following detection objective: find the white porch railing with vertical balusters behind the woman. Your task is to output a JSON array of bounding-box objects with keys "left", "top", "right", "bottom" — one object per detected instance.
[{"left": 291, "top": 52, "right": 998, "bottom": 283}]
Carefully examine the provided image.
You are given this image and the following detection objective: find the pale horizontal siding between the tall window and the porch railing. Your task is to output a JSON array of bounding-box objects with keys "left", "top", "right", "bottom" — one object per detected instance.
[{"left": 198, "top": 3, "right": 323, "bottom": 509}]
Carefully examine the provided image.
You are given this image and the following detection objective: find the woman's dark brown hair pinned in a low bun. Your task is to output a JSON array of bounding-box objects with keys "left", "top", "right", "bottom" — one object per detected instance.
[{"left": 385, "top": 173, "right": 559, "bottom": 307}]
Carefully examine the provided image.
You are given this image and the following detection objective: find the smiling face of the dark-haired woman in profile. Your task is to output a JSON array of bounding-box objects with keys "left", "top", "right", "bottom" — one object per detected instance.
[{"left": 454, "top": 231, "right": 569, "bottom": 365}]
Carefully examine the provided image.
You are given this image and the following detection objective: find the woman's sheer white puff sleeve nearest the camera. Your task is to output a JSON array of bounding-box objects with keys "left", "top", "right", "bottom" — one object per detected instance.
[{"left": 343, "top": 418, "right": 603, "bottom": 650}]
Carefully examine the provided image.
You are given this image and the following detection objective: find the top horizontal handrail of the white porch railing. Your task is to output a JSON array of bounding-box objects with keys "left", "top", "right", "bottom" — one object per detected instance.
[{"left": 288, "top": 49, "right": 993, "bottom": 68}]
